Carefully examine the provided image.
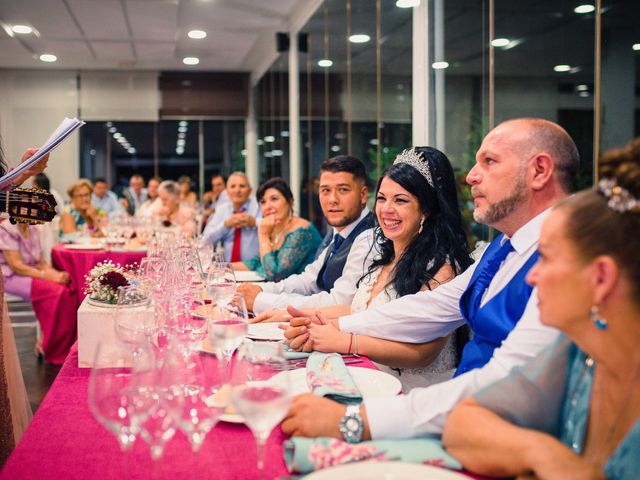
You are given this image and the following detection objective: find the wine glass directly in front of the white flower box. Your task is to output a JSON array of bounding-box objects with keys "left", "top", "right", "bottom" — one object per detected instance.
[{"left": 115, "top": 285, "right": 158, "bottom": 355}]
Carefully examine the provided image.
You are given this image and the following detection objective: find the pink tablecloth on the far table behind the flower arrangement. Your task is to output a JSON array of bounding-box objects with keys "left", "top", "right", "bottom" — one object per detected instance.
[{"left": 51, "top": 245, "right": 147, "bottom": 309}]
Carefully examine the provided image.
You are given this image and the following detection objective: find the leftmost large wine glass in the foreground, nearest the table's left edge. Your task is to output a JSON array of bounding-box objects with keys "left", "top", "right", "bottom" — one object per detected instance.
[{"left": 88, "top": 342, "right": 151, "bottom": 452}]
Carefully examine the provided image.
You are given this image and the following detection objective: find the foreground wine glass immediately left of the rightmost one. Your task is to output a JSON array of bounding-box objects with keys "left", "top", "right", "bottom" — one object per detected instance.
[{"left": 160, "top": 347, "right": 228, "bottom": 452}]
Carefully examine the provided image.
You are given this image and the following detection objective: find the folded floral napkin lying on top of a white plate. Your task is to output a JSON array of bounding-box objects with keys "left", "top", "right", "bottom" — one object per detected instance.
[{"left": 307, "top": 352, "right": 362, "bottom": 404}]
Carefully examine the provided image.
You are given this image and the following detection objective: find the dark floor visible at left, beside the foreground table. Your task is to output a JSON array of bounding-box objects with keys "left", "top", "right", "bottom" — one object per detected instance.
[{"left": 8, "top": 301, "right": 60, "bottom": 413}]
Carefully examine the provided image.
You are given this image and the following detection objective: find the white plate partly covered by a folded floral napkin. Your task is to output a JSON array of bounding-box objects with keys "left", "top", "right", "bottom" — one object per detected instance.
[{"left": 269, "top": 367, "right": 402, "bottom": 398}]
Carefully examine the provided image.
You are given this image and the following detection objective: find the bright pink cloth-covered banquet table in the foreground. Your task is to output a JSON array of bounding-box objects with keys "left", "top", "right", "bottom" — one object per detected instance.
[{"left": 0, "top": 343, "right": 488, "bottom": 480}]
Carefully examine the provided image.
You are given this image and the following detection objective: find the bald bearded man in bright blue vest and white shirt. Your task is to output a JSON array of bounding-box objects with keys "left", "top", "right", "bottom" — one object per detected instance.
[{"left": 283, "top": 118, "right": 579, "bottom": 442}]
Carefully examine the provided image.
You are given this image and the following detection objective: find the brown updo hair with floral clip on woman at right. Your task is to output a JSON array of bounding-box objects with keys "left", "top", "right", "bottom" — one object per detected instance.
[{"left": 558, "top": 138, "right": 640, "bottom": 302}]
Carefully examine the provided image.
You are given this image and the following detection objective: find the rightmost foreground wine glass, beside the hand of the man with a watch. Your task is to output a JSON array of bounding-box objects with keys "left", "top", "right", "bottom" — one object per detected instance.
[{"left": 231, "top": 342, "right": 291, "bottom": 473}]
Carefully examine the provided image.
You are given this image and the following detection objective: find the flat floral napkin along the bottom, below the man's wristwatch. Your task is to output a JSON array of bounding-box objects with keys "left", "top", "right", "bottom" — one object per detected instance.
[{"left": 284, "top": 437, "right": 462, "bottom": 473}]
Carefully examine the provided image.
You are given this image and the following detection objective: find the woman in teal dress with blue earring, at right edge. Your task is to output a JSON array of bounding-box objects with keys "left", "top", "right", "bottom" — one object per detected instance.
[{"left": 444, "top": 141, "right": 640, "bottom": 480}]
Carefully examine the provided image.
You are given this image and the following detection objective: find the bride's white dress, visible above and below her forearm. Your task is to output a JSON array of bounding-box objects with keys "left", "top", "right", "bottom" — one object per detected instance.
[{"left": 351, "top": 268, "right": 456, "bottom": 393}]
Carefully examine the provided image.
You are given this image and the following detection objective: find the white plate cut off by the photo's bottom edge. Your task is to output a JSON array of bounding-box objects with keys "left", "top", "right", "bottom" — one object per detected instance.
[{"left": 304, "top": 462, "right": 469, "bottom": 480}]
